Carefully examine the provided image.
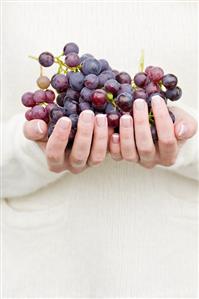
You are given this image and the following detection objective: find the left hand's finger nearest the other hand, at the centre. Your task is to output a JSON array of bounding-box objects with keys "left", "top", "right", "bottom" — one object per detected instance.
[{"left": 88, "top": 114, "right": 108, "bottom": 166}]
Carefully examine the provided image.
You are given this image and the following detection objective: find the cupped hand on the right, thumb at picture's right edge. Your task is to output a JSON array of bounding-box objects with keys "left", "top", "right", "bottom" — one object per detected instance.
[{"left": 109, "top": 96, "right": 197, "bottom": 168}]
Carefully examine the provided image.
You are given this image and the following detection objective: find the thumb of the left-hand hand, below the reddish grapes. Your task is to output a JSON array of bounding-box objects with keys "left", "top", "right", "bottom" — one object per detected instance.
[{"left": 23, "top": 119, "right": 48, "bottom": 141}]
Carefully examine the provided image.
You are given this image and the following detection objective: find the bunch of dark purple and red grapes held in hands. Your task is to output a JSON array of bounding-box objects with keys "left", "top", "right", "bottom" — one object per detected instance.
[{"left": 22, "top": 42, "right": 182, "bottom": 146}]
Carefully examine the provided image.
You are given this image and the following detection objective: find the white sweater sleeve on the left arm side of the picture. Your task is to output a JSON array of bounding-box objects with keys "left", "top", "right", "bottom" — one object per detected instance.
[{"left": 0, "top": 114, "right": 65, "bottom": 197}]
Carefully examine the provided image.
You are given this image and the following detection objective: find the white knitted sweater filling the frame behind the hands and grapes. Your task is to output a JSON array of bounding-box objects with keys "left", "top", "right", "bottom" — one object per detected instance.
[{"left": 1, "top": 2, "right": 199, "bottom": 298}]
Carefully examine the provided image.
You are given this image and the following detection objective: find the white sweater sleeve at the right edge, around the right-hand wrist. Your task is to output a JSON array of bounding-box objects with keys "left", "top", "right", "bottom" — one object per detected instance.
[{"left": 159, "top": 103, "right": 199, "bottom": 181}]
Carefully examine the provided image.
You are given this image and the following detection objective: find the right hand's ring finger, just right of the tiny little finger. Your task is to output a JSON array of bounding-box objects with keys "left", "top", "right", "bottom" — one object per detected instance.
[{"left": 120, "top": 115, "right": 138, "bottom": 162}]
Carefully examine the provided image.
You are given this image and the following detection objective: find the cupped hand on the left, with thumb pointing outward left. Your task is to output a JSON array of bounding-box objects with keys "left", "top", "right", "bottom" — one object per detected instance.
[{"left": 24, "top": 110, "right": 108, "bottom": 174}]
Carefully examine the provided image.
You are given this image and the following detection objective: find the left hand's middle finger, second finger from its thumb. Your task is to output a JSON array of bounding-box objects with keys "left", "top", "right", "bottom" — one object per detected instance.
[{"left": 69, "top": 110, "right": 94, "bottom": 168}]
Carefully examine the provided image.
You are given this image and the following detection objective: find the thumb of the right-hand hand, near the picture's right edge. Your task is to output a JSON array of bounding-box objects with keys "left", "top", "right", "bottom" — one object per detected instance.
[{"left": 174, "top": 121, "right": 197, "bottom": 140}]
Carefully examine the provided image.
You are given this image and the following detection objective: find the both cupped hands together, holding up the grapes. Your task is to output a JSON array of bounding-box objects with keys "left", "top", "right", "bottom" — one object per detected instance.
[{"left": 24, "top": 96, "right": 197, "bottom": 174}]
